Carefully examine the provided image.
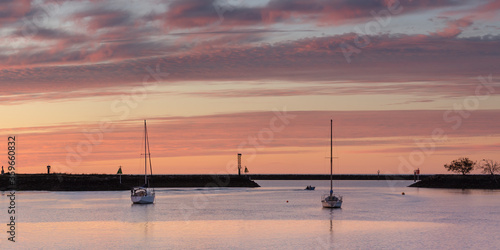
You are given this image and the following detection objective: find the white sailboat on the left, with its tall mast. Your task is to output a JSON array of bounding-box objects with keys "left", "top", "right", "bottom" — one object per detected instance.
[{"left": 130, "top": 120, "right": 155, "bottom": 204}]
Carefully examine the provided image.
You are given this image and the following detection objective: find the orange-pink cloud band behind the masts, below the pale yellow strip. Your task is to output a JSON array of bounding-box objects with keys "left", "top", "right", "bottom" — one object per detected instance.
[{"left": 10, "top": 110, "right": 500, "bottom": 172}]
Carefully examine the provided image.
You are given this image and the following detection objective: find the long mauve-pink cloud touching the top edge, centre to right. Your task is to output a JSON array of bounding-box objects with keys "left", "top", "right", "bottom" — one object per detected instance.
[{"left": 156, "top": 0, "right": 467, "bottom": 29}]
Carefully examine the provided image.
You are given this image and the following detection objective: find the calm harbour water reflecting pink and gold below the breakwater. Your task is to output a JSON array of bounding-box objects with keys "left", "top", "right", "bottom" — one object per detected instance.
[{"left": 0, "top": 181, "right": 500, "bottom": 249}]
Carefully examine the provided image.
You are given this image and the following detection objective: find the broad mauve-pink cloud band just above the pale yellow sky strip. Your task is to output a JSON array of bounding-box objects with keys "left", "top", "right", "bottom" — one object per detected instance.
[{"left": 0, "top": 31, "right": 500, "bottom": 100}]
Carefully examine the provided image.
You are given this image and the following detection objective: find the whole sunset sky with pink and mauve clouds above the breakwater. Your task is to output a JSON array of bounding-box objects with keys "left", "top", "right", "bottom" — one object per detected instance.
[{"left": 0, "top": 0, "right": 500, "bottom": 174}]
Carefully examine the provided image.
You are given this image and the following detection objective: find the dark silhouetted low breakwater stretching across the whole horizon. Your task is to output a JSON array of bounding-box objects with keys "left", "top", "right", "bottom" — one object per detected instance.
[{"left": 4, "top": 173, "right": 500, "bottom": 191}]
